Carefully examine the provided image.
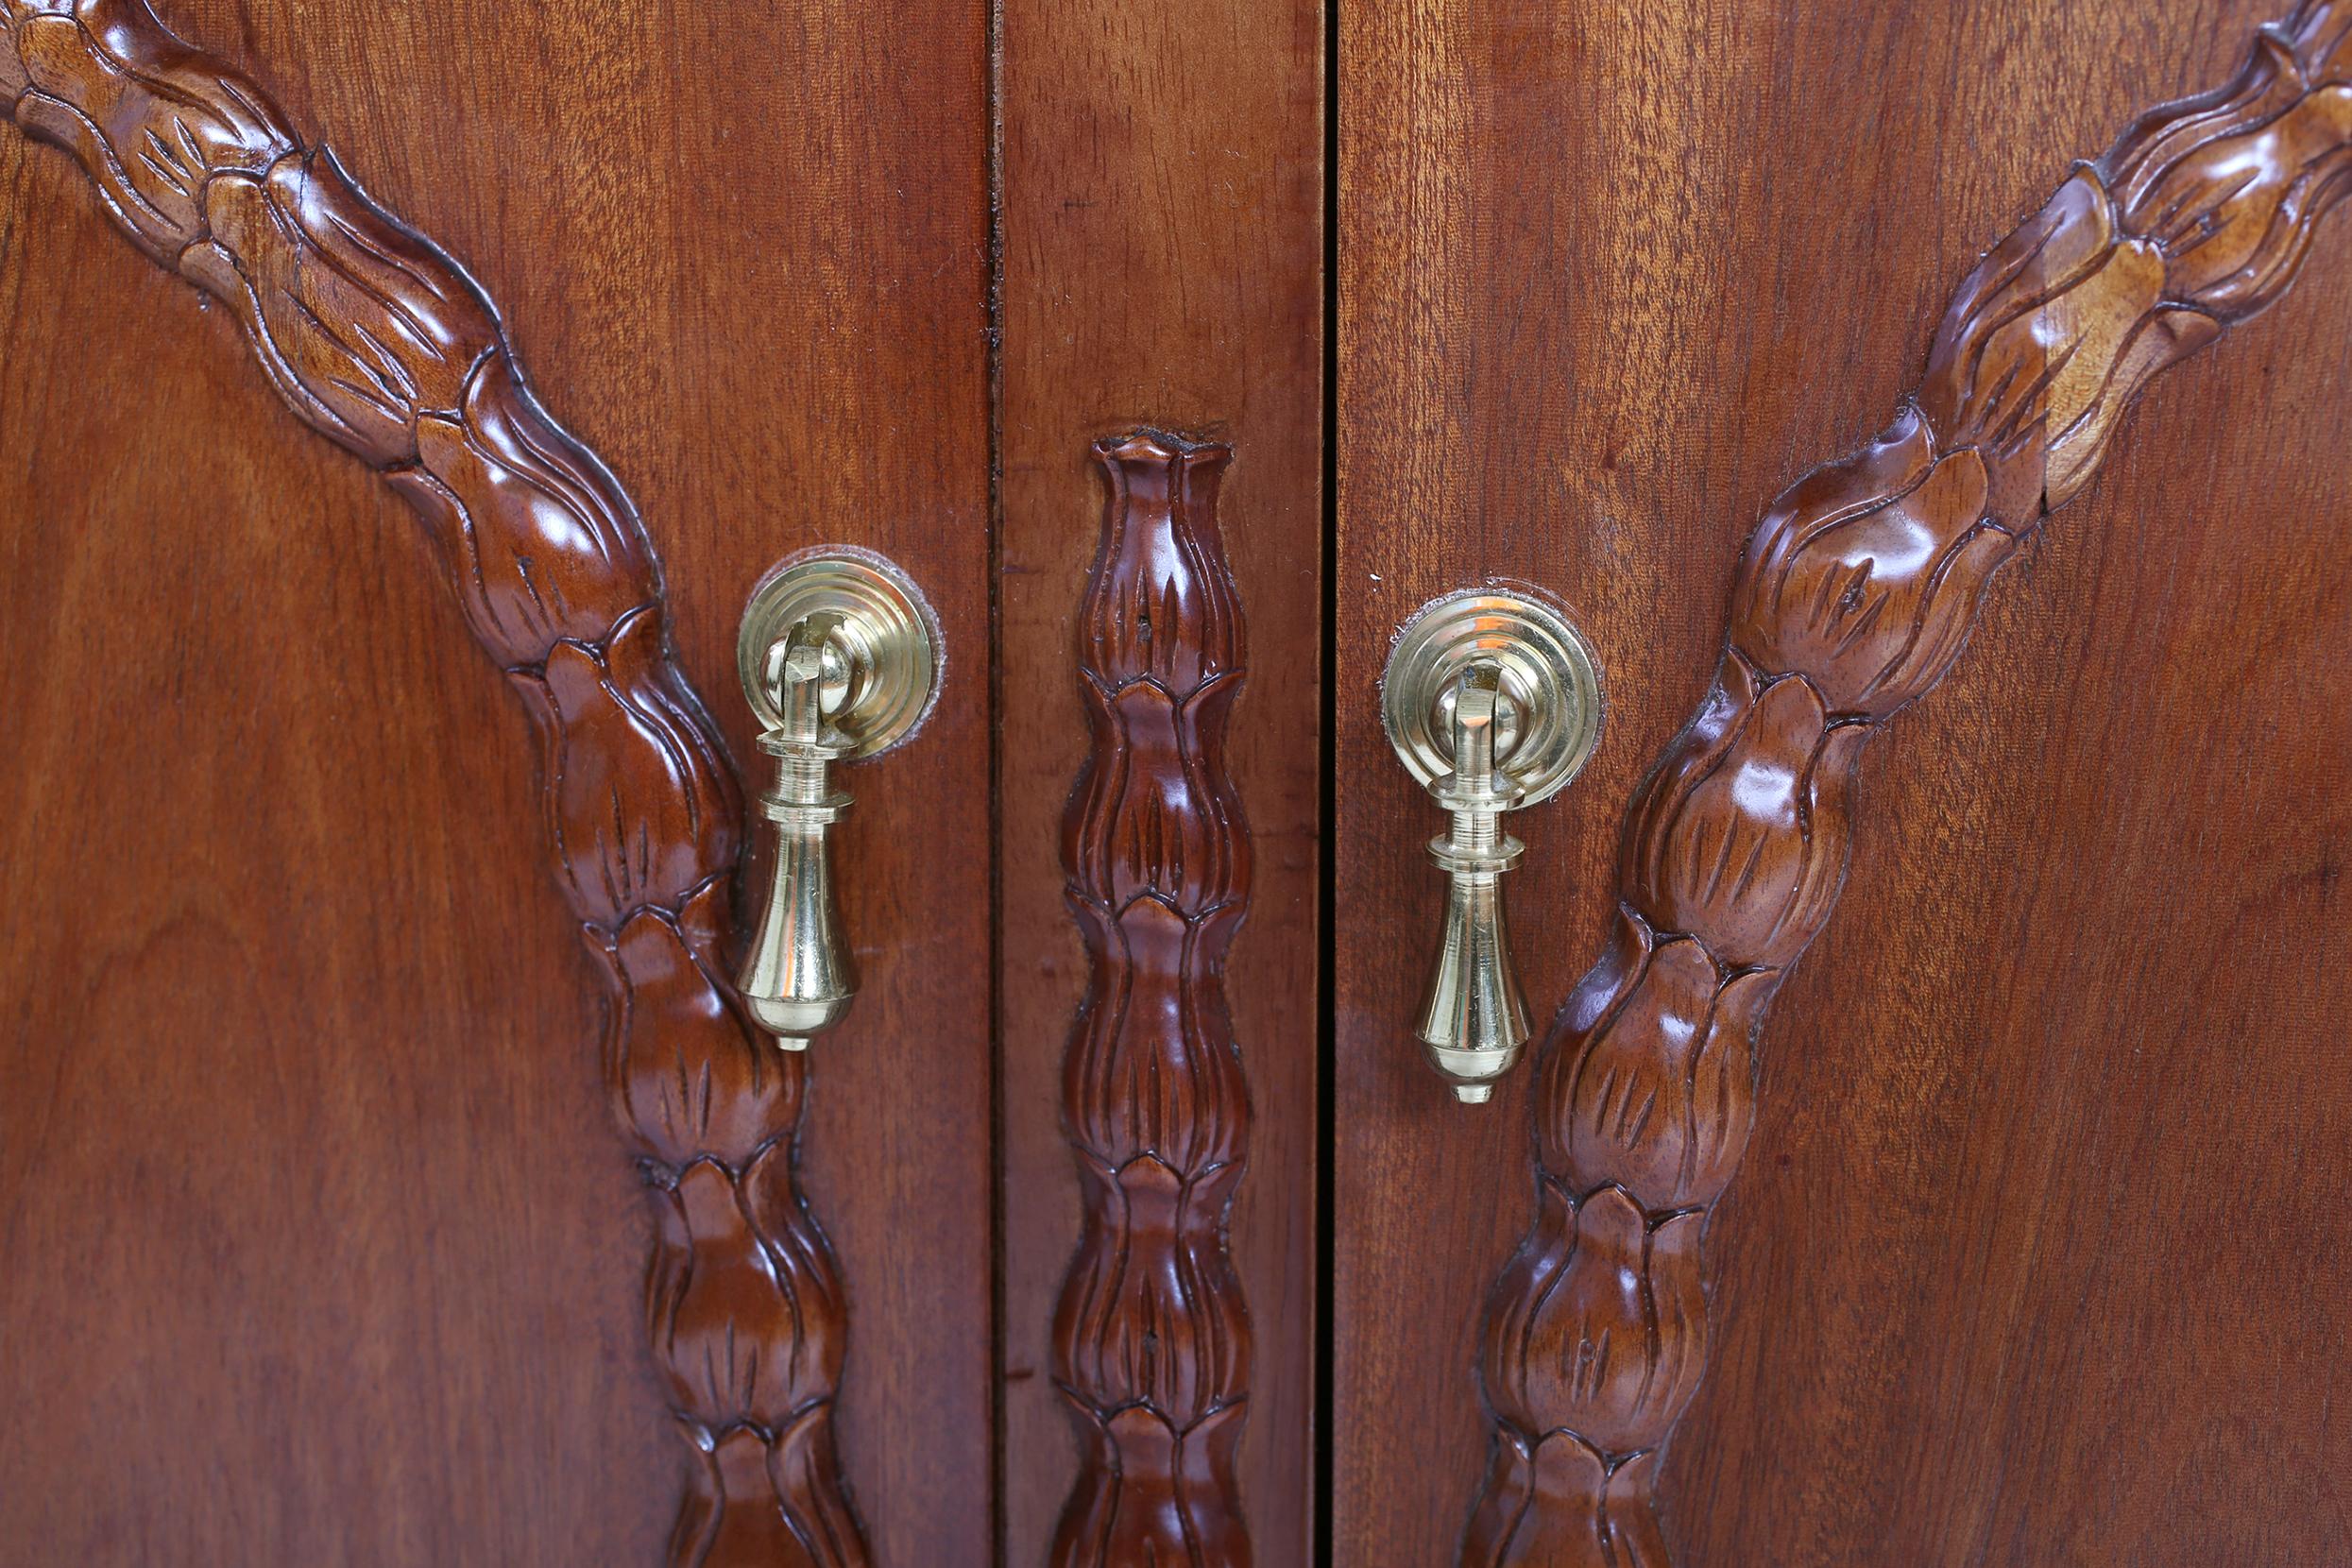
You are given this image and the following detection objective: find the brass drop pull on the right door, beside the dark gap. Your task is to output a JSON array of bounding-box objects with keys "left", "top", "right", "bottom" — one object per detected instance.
[{"left": 1381, "top": 590, "right": 1602, "bottom": 1105}]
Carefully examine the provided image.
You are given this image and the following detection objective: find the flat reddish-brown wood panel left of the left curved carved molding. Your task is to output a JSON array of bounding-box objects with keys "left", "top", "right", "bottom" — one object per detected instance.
[{"left": 0, "top": 134, "right": 682, "bottom": 1566}]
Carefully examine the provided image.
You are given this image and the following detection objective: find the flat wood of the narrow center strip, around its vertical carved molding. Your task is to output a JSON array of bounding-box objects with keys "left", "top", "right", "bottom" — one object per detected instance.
[{"left": 997, "top": 0, "right": 1324, "bottom": 1563}]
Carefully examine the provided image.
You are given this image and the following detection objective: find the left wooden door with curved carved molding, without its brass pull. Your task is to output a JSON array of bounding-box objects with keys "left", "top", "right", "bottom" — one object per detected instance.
[{"left": 0, "top": 0, "right": 993, "bottom": 1563}]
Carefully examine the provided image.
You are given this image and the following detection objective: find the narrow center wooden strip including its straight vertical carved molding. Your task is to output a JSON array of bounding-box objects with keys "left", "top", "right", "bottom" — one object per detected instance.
[{"left": 997, "top": 0, "right": 1326, "bottom": 1568}]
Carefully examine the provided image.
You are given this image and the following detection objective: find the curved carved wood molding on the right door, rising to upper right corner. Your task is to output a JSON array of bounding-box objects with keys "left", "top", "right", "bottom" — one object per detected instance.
[{"left": 1463, "top": 0, "right": 2352, "bottom": 1568}]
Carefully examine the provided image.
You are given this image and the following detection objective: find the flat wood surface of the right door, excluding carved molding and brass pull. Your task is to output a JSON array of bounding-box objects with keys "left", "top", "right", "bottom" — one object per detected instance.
[{"left": 1334, "top": 5, "right": 2352, "bottom": 1566}]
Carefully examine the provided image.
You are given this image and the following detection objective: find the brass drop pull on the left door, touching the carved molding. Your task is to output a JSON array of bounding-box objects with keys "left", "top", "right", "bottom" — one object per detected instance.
[{"left": 736, "top": 550, "right": 939, "bottom": 1050}]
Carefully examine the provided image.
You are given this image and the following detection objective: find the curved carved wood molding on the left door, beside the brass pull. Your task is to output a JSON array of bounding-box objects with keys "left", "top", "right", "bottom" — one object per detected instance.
[{"left": 0, "top": 0, "right": 865, "bottom": 1568}]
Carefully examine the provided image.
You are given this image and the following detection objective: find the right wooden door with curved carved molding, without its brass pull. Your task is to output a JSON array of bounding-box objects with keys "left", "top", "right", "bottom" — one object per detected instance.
[{"left": 1331, "top": 0, "right": 2352, "bottom": 1568}]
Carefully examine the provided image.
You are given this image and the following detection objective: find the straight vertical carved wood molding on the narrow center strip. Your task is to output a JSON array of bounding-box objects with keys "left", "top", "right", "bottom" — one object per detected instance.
[{"left": 1054, "top": 430, "right": 1249, "bottom": 1568}]
